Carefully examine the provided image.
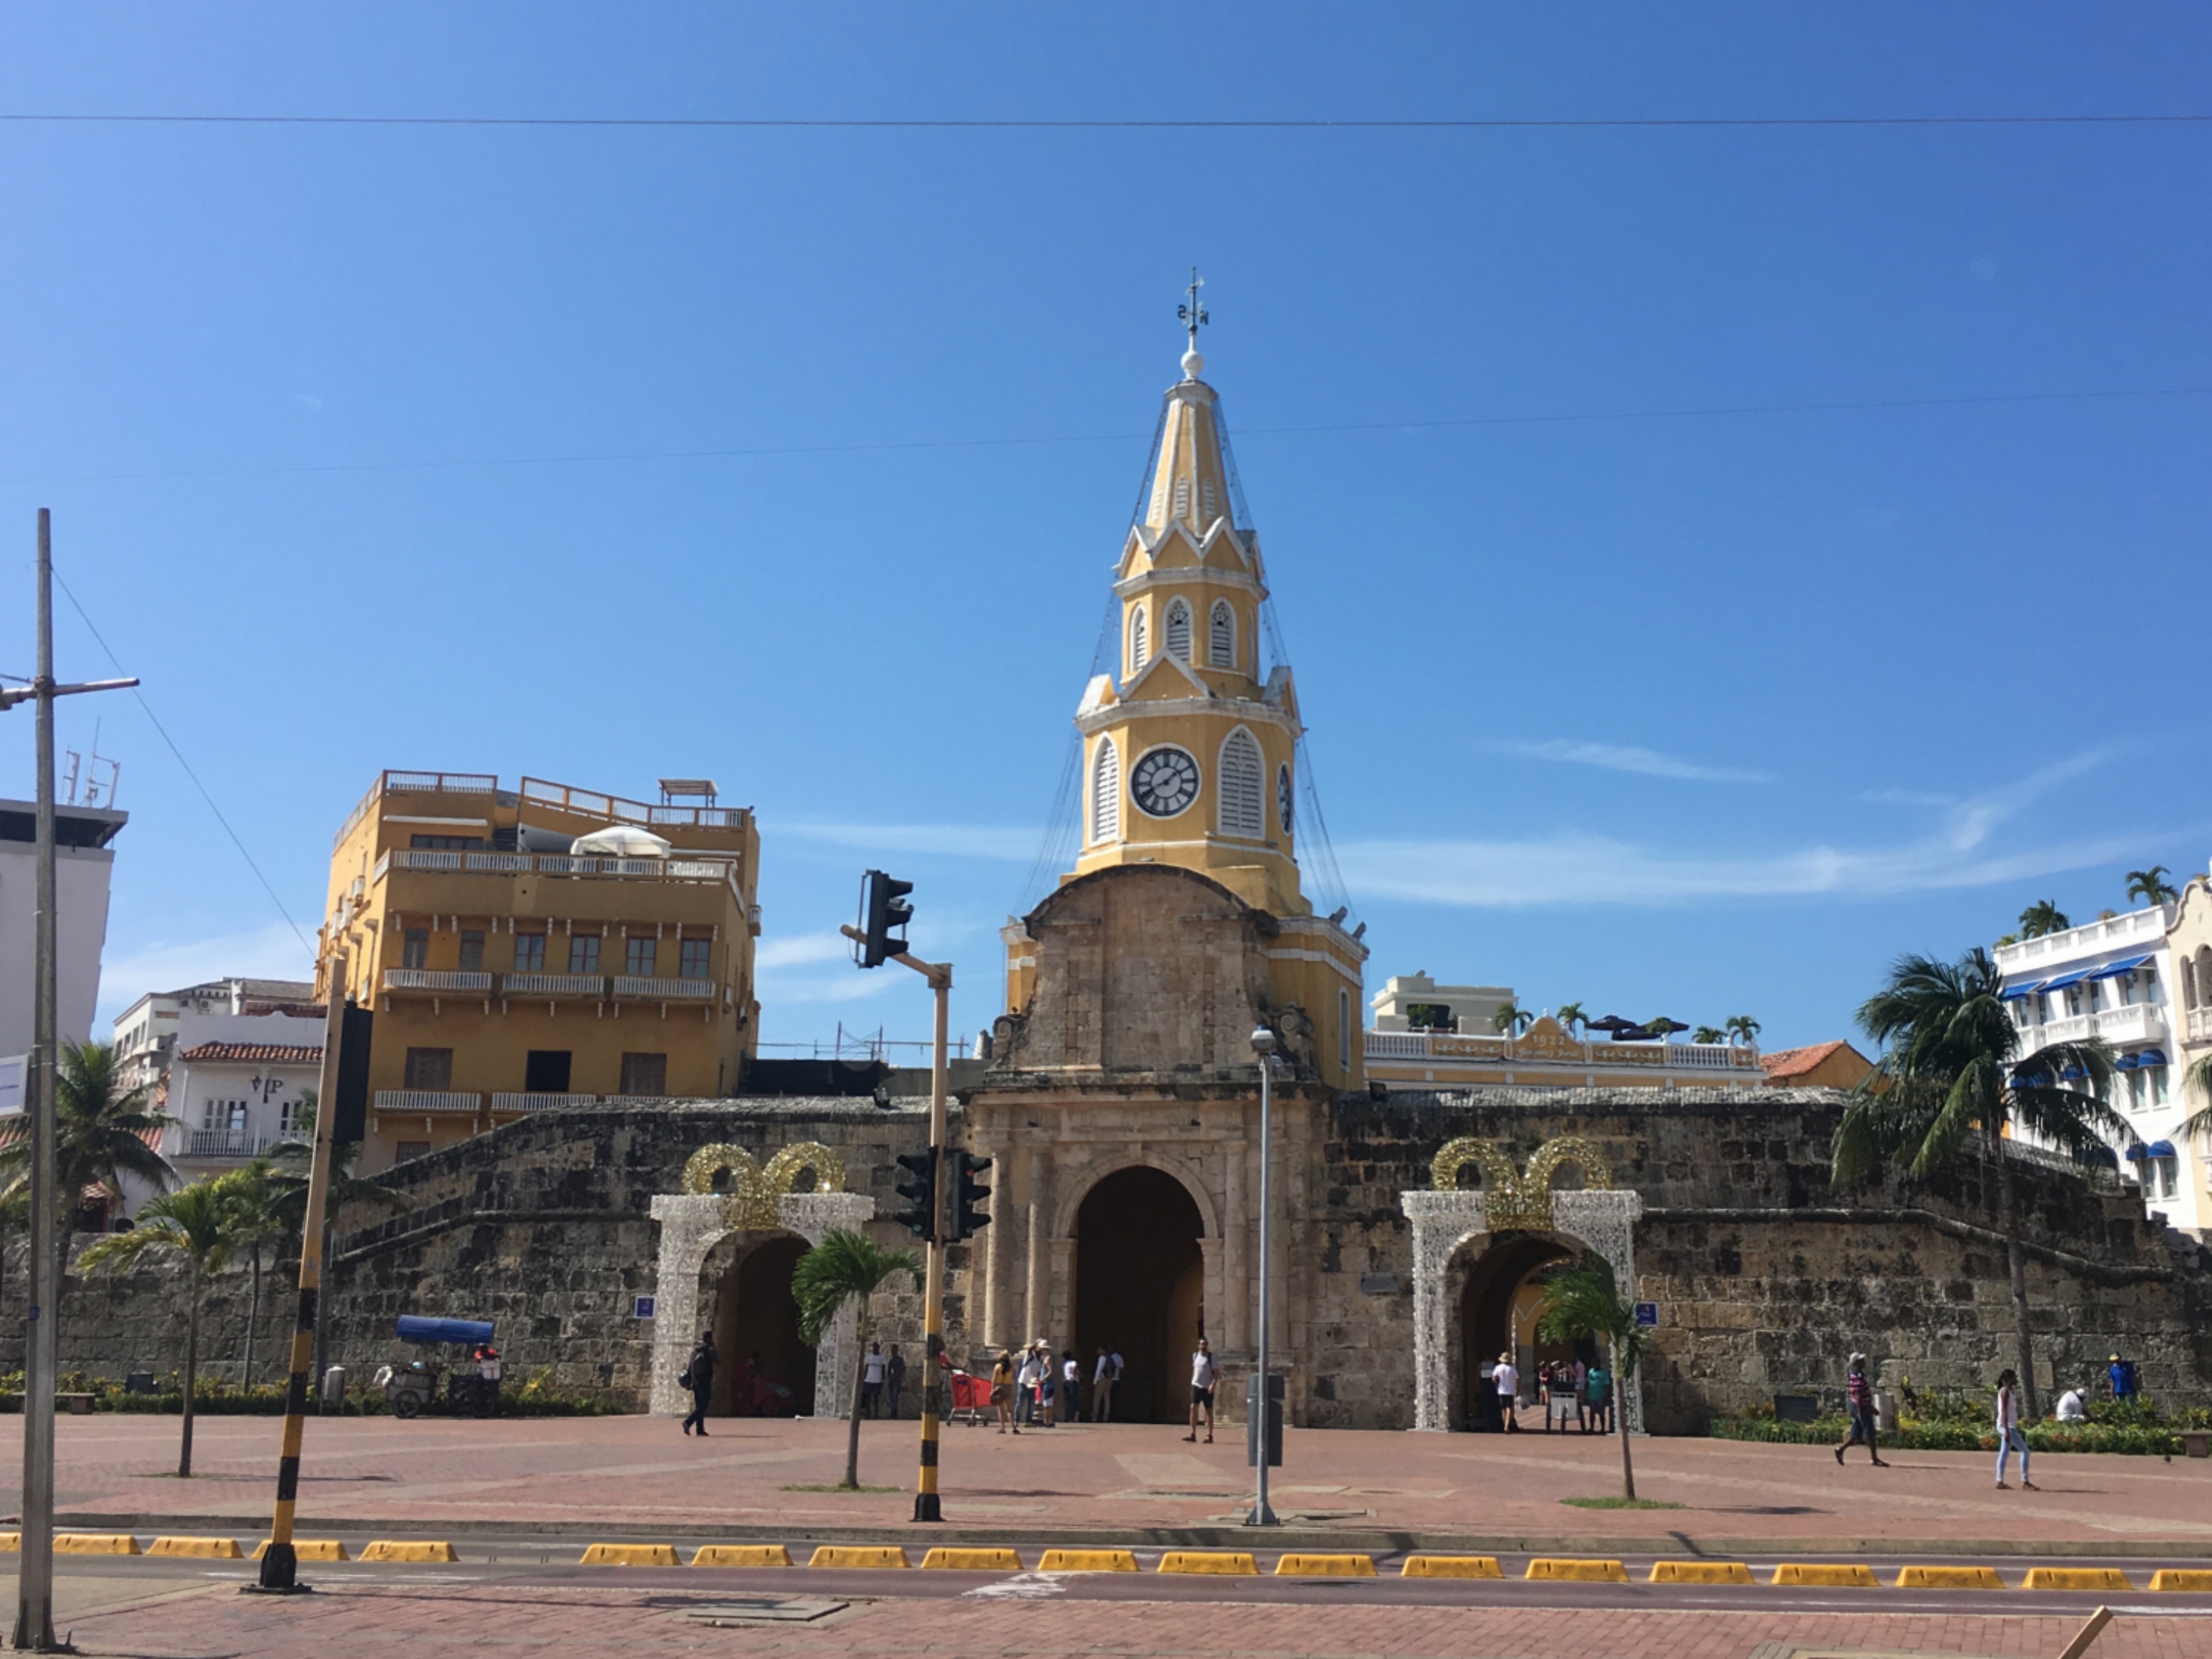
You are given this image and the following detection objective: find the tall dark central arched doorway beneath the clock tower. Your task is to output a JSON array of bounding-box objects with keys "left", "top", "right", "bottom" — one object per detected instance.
[{"left": 1075, "top": 1168, "right": 1206, "bottom": 1422}]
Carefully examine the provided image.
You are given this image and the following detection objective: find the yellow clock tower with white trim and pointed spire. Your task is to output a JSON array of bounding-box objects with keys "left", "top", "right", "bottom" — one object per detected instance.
[{"left": 1004, "top": 343, "right": 1367, "bottom": 1089}]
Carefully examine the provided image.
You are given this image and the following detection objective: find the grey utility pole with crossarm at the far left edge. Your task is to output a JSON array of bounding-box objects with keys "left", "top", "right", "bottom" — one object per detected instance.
[{"left": 0, "top": 507, "right": 137, "bottom": 1652}]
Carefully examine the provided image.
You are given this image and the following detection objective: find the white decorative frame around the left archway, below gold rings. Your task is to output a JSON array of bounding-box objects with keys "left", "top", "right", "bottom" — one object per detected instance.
[{"left": 652, "top": 1193, "right": 876, "bottom": 1418}]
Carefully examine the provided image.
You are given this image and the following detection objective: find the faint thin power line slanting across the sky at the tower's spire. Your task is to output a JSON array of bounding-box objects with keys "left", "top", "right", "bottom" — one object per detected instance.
[{"left": 0, "top": 385, "right": 2212, "bottom": 484}]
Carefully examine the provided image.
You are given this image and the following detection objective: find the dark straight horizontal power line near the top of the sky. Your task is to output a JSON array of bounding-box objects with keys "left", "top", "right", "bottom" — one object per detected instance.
[{"left": 0, "top": 111, "right": 2212, "bottom": 133}]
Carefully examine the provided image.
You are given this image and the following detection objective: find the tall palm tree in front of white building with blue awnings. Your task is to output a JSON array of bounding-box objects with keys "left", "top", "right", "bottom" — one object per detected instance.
[{"left": 1829, "top": 945, "right": 2128, "bottom": 1416}]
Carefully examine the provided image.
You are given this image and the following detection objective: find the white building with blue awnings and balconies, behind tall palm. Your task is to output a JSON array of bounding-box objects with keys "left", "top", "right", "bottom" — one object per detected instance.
[{"left": 1996, "top": 904, "right": 2212, "bottom": 1232}]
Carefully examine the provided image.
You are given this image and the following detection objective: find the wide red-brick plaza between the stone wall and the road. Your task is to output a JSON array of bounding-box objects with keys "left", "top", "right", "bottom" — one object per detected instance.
[{"left": 13, "top": 1416, "right": 2212, "bottom": 1557}]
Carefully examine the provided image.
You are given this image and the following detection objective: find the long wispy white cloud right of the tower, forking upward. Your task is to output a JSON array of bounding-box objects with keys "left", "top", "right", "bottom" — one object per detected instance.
[{"left": 1338, "top": 755, "right": 2141, "bottom": 909}]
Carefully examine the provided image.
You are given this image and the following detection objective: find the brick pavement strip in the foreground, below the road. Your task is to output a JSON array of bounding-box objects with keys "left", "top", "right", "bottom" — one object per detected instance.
[{"left": 7, "top": 1580, "right": 2212, "bottom": 1659}]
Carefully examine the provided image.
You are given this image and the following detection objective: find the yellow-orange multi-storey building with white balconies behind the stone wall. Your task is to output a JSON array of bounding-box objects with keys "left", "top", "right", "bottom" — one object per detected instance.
[{"left": 316, "top": 772, "right": 761, "bottom": 1170}]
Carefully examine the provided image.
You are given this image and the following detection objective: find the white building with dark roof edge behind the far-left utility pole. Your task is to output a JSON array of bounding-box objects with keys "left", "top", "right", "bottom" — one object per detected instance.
[{"left": 0, "top": 801, "right": 130, "bottom": 1112}]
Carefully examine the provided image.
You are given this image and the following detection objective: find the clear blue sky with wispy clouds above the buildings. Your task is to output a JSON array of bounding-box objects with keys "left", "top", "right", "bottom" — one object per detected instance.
[{"left": 0, "top": 4, "right": 2212, "bottom": 1047}]
